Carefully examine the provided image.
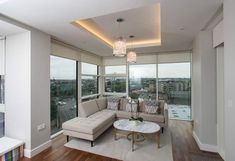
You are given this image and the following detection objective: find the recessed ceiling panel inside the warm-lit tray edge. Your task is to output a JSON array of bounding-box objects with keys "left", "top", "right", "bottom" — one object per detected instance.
[{"left": 86, "top": 5, "right": 162, "bottom": 41}]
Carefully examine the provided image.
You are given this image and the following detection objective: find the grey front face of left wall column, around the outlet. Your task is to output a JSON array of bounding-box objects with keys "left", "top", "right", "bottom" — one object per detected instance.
[{"left": 31, "top": 30, "right": 51, "bottom": 149}]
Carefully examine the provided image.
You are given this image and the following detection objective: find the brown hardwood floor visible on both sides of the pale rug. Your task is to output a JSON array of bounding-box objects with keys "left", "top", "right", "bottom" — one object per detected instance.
[{"left": 21, "top": 120, "right": 222, "bottom": 161}]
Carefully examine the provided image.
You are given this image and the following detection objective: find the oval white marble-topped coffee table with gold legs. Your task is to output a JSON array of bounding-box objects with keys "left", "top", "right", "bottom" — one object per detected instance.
[{"left": 113, "top": 119, "right": 160, "bottom": 151}]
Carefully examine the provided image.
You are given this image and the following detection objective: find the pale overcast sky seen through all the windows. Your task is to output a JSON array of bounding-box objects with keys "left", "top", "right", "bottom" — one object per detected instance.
[{"left": 51, "top": 56, "right": 190, "bottom": 80}]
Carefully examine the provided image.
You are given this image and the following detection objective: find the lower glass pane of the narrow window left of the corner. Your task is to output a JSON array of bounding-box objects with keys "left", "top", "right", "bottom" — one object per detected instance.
[{"left": 82, "top": 76, "right": 98, "bottom": 96}]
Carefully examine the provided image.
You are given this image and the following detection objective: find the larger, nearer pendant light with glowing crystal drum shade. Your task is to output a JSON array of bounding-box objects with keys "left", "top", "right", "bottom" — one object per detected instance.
[{"left": 113, "top": 18, "right": 126, "bottom": 57}]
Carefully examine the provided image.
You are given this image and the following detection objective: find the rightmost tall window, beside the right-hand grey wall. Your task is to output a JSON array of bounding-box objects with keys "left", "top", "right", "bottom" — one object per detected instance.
[{"left": 158, "top": 62, "right": 191, "bottom": 120}]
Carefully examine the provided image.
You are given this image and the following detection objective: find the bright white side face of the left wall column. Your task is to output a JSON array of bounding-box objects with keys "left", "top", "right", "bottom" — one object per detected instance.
[{"left": 5, "top": 32, "right": 31, "bottom": 149}]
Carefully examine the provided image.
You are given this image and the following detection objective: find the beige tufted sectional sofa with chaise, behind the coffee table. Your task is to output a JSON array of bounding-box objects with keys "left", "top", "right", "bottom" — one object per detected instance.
[{"left": 62, "top": 97, "right": 168, "bottom": 146}]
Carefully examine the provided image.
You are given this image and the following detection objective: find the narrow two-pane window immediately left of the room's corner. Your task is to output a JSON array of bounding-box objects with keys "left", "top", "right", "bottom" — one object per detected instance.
[{"left": 81, "top": 62, "right": 99, "bottom": 101}]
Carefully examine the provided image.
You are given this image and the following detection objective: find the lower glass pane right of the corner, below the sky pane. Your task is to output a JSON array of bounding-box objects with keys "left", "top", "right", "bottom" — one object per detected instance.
[{"left": 105, "top": 77, "right": 126, "bottom": 93}]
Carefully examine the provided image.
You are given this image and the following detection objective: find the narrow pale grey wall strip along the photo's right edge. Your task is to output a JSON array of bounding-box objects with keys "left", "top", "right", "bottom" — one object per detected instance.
[{"left": 224, "top": 0, "right": 235, "bottom": 161}]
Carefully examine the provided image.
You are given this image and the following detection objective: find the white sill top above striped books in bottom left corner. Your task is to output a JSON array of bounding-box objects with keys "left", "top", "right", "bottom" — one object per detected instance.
[{"left": 0, "top": 136, "right": 24, "bottom": 156}]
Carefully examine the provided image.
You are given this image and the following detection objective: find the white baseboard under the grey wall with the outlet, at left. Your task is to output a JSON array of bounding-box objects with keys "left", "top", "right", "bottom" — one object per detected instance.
[{"left": 24, "top": 140, "right": 51, "bottom": 158}]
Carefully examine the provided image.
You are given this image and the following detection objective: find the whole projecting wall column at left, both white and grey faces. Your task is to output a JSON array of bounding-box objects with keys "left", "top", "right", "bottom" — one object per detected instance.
[{"left": 0, "top": 15, "right": 51, "bottom": 157}]
